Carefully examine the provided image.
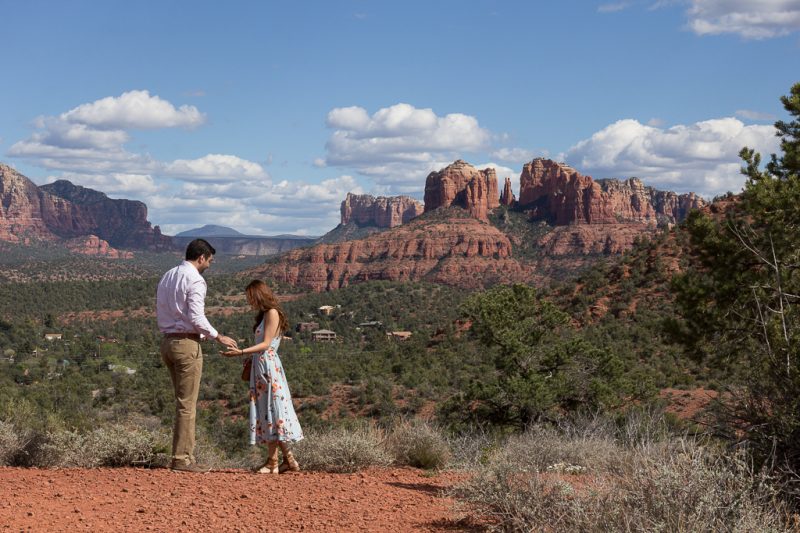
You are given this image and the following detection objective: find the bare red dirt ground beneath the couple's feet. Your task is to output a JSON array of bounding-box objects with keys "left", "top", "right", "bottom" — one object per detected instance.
[{"left": 0, "top": 468, "right": 466, "bottom": 532}]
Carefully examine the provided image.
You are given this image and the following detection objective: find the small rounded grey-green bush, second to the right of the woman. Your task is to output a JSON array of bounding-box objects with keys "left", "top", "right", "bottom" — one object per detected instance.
[{"left": 386, "top": 419, "right": 452, "bottom": 469}]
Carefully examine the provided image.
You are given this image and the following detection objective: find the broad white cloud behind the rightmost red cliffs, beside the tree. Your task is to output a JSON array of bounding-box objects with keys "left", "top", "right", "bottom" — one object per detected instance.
[{"left": 559, "top": 118, "right": 779, "bottom": 197}]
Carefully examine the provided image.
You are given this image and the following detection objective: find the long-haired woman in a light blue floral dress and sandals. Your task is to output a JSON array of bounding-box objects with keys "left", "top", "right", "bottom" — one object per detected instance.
[{"left": 223, "top": 280, "right": 303, "bottom": 474}]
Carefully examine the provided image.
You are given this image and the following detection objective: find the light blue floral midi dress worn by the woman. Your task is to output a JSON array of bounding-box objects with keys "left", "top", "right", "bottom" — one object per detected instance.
[{"left": 245, "top": 320, "right": 303, "bottom": 444}]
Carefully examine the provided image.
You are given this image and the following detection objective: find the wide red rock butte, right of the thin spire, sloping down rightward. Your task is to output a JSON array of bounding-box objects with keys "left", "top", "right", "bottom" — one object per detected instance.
[{"left": 519, "top": 158, "right": 705, "bottom": 226}]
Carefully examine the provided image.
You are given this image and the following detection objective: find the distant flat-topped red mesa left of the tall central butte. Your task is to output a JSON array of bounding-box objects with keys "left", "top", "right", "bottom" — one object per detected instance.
[{"left": 341, "top": 193, "right": 424, "bottom": 228}]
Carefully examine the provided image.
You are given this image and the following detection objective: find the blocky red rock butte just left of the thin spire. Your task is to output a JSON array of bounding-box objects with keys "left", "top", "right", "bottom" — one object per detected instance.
[{"left": 425, "top": 159, "right": 500, "bottom": 220}]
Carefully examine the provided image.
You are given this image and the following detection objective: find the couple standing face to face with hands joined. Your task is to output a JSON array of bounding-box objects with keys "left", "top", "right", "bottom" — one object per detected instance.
[{"left": 156, "top": 239, "right": 303, "bottom": 474}]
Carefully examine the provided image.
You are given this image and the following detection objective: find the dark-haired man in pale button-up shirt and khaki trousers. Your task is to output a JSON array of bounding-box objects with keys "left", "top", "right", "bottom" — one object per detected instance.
[{"left": 156, "top": 239, "right": 237, "bottom": 472}]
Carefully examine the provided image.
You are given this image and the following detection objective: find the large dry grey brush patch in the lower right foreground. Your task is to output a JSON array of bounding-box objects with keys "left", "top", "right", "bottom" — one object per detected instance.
[{"left": 454, "top": 414, "right": 792, "bottom": 532}]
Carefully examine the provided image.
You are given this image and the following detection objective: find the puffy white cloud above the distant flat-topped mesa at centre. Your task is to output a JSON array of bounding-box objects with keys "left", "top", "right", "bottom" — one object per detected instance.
[{"left": 325, "top": 103, "right": 491, "bottom": 189}]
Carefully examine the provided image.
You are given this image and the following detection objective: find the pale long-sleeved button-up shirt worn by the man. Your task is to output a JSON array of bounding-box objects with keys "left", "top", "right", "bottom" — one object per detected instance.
[{"left": 156, "top": 261, "right": 219, "bottom": 339}]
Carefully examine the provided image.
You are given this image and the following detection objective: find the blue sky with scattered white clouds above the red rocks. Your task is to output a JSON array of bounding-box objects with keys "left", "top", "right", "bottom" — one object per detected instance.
[{"left": 0, "top": 0, "right": 800, "bottom": 235}]
